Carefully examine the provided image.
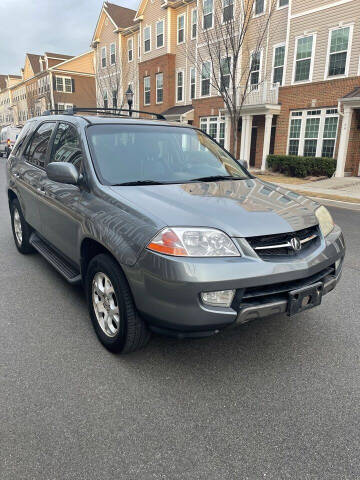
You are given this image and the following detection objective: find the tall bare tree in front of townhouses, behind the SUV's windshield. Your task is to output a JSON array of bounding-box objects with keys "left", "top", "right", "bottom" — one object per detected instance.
[{"left": 187, "top": 0, "right": 276, "bottom": 156}]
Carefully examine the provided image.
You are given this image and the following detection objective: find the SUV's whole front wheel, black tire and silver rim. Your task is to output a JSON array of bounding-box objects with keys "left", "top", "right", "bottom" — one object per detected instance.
[{"left": 85, "top": 254, "right": 150, "bottom": 353}]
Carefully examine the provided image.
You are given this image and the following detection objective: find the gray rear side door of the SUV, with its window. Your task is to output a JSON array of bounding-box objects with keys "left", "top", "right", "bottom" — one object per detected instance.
[{"left": 12, "top": 122, "right": 56, "bottom": 234}]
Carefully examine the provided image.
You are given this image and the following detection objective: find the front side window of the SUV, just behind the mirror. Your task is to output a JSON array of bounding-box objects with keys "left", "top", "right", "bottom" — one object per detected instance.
[{"left": 50, "top": 123, "right": 82, "bottom": 173}]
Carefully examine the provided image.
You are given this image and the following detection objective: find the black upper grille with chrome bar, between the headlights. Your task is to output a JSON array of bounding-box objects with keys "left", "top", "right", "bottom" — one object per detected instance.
[{"left": 247, "top": 225, "right": 320, "bottom": 260}]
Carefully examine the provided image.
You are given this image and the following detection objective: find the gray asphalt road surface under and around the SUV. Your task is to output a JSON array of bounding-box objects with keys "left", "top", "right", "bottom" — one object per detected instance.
[{"left": 0, "top": 162, "right": 360, "bottom": 480}]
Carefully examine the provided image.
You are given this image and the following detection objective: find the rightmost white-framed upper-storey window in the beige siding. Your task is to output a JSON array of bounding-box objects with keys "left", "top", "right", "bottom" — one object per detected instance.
[{"left": 327, "top": 27, "right": 350, "bottom": 77}]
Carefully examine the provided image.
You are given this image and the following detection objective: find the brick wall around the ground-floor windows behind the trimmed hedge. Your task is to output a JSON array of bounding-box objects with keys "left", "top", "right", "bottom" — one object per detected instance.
[{"left": 275, "top": 77, "right": 360, "bottom": 170}]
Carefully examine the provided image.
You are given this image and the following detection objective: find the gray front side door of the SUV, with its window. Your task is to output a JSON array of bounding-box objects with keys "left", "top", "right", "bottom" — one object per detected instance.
[{"left": 40, "top": 122, "right": 88, "bottom": 263}]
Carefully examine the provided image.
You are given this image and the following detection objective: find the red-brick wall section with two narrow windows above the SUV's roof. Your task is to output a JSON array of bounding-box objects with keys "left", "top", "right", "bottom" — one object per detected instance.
[{"left": 139, "top": 53, "right": 175, "bottom": 113}]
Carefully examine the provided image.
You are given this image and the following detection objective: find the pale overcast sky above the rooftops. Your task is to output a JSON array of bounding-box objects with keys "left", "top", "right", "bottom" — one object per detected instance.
[{"left": 0, "top": 0, "right": 139, "bottom": 75}]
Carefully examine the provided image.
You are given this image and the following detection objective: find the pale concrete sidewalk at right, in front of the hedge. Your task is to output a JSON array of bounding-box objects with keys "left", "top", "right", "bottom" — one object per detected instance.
[{"left": 255, "top": 175, "right": 360, "bottom": 203}]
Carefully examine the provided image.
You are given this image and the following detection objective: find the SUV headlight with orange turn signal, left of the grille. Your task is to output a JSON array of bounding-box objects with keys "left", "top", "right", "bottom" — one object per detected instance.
[{"left": 147, "top": 227, "right": 240, "bottom": 257}]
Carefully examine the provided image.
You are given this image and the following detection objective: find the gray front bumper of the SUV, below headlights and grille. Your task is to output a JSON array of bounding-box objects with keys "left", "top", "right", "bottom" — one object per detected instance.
[{"left": 124, "top": 227, "right": 345, "bottom": 336}]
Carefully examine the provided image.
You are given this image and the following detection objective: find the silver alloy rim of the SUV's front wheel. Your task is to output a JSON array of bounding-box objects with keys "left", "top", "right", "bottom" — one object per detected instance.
[{"left": 92, "top": 272, "right": 120, "bottom": 337}]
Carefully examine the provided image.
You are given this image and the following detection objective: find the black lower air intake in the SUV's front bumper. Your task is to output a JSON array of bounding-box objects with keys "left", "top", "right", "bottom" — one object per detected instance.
[{"left": 232, "top": 265, "right": 335, "bottom": 311}]
